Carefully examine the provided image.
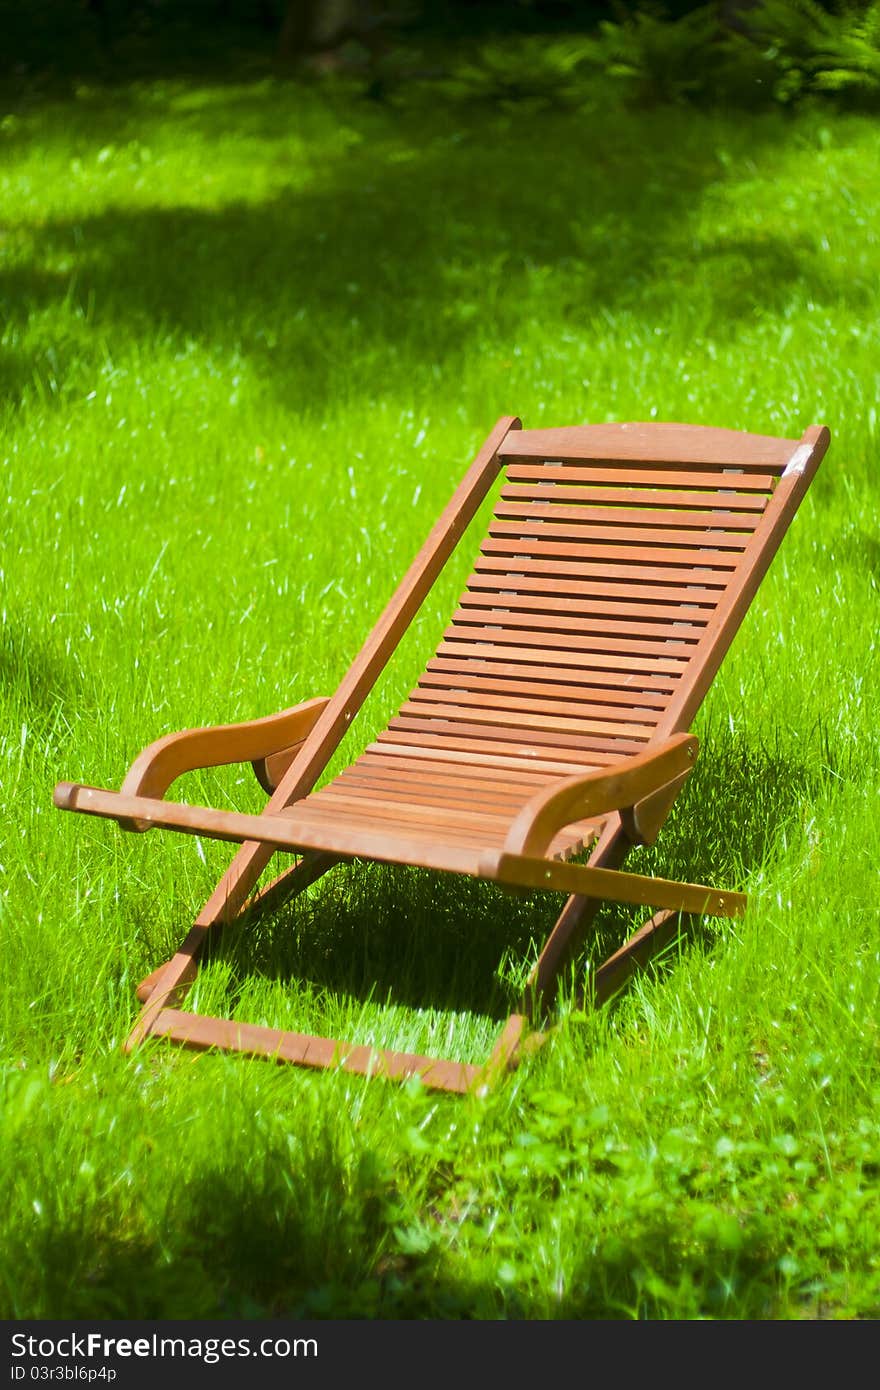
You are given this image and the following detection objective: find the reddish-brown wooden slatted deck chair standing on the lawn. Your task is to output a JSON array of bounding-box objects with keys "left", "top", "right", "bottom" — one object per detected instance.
[{"left": 54, "top": 417, "right": 830, "bottom": 1091}]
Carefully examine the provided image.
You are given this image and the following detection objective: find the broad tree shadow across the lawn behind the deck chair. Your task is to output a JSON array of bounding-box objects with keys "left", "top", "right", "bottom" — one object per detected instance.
[{"left": 0, "top": 89, "right": 867, "bottom": 413}]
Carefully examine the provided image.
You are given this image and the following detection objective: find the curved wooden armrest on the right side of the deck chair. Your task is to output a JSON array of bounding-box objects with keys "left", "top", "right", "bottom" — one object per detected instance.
[{"left": 503, "top": 734, "right": 699, "bottom": 856}]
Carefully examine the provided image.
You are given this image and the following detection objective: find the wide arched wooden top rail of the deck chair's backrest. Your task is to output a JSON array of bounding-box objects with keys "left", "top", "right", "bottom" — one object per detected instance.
[{"left": 498, "top": 421, "right": 798, "bottom": 473}]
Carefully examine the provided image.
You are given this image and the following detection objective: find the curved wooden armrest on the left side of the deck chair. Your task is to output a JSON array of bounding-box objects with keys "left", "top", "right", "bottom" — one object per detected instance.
[{"left": 113, "top": 696, "right": 327, "bottom": 799}]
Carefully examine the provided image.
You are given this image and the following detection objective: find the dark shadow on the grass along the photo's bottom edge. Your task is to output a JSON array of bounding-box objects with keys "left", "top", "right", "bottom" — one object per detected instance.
[{"left": 4, "top": 1147, "right": 800, "bottom": 1319}]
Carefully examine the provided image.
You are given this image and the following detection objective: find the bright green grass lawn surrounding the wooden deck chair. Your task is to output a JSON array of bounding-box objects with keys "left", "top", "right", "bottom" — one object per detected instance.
[{"left": 0, "top": 67, "right": 880, "bottom": 1319}]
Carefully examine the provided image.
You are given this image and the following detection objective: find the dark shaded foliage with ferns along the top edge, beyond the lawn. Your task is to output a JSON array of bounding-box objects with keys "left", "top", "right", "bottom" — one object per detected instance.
[{"left": 0, "top": 0, "right": 880, "bottom": 111}]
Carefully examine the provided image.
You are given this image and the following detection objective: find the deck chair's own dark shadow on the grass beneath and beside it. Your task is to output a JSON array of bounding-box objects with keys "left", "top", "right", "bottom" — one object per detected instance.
[{"left": 189, "top": 738, "right": 820, "bottom": 1019}]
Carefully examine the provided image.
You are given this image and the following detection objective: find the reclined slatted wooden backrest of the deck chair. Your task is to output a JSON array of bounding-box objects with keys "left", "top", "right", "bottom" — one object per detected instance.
[{"left": 388, "top": 424, "right": 830, "bottom": 770}]
